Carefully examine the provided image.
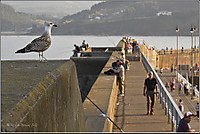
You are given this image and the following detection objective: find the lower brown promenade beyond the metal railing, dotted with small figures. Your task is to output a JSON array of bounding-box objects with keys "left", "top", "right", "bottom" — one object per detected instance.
[{"left": 158, "top": 70, "right": 199, "bottom": 132}]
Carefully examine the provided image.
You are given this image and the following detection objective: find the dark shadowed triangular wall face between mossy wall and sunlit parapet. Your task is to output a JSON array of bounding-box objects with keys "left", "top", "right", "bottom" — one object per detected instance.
[{"left": 71, "top": 55, "right": 110, "bottom": 101}]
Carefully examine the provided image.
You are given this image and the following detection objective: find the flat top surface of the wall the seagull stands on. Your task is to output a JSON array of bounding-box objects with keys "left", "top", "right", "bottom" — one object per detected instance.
[{"left": 1, "top": 60, "right": 67, "bottom": 119}]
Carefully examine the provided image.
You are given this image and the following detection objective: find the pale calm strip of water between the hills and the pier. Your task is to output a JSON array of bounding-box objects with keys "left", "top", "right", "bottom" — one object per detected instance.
[{"left": 1, "top": 35, "right": 199, "bottom": 60}]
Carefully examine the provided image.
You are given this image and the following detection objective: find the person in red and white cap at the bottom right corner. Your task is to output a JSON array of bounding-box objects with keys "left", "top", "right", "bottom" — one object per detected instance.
[{"left": 177, "top": 112, "right": 195, "bottom": 132}]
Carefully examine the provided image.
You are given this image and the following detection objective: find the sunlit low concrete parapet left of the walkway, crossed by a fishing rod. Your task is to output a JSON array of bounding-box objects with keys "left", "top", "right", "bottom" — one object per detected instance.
[{"left": 83, "top": 52, "right": 121, "bottom": 132}]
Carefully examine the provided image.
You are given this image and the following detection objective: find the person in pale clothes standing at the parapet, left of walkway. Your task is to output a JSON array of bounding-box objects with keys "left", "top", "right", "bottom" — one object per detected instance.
[{"left": 113, "top": 61, "right": 125, "bottom": 96}]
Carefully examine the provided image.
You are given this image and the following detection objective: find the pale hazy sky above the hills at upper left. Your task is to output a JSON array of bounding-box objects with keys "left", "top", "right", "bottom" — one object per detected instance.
[{"left": 1, "top": 0, "right": 101, "bottom": 18}]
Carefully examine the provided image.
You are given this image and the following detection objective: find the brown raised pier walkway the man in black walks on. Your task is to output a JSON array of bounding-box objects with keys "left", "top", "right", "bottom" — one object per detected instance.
[{"left": 113, "top": 61, "right": 171, "bottom": 132}]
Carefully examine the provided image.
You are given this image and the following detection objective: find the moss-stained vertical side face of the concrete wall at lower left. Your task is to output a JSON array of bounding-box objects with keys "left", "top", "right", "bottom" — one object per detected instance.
[{"left": 1, "top": 61, "right": 86, "bottom": 132}]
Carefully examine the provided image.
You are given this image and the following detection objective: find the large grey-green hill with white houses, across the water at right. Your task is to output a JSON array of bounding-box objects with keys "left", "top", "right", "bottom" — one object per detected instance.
[{"left": 1, "top": 0, "right": 199, "bottom": 36}]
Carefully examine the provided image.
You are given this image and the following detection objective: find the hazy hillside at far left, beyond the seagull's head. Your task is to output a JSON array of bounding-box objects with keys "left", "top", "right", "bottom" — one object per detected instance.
[{"left": 0, "top": 3, "right": 57, "bottom": 33}]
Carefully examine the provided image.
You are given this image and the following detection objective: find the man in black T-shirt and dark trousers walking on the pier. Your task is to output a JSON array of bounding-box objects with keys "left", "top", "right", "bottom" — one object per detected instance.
[{"left": 143, "top": 72, "right": 158, "bottom": 115}]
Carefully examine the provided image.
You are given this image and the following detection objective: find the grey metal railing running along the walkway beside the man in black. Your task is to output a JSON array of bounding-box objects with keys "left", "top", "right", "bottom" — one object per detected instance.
[{"left": 141, "top": 52, "right": 183, "bottom": 131}]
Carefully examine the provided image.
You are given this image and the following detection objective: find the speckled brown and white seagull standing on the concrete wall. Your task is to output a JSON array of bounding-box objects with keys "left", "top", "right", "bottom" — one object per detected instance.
[{"left": 15, "top": 22, "right": 57, "bottom": 62}]
